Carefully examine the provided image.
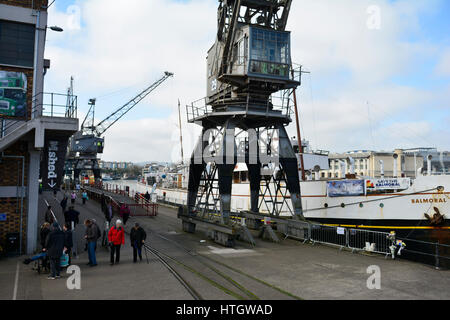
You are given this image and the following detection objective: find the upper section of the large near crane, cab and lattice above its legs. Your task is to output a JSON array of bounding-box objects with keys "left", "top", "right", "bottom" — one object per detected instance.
[{"left": 207, "top": 0, "right": 299, "bottom": 111}]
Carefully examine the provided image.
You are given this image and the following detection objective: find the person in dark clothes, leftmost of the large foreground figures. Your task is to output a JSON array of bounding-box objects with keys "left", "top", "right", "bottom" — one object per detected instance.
[{"left": 43, "top": 222, "right": 65, "bottom": 280}]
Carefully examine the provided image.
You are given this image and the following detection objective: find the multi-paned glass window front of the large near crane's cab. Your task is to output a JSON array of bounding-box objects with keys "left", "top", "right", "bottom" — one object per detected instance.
[{"left": 249, "top": 28, "right": 291, "bottom": 78}]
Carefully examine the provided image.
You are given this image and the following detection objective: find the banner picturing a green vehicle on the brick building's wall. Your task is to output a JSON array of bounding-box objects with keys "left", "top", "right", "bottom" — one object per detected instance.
[{"left": 0, "top": 70, "right": 27, "bottom": 117}]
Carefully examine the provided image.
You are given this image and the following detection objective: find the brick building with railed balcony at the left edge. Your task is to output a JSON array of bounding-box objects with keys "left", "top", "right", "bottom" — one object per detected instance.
[{"left": 0, "top": 0, "right": 78, "bottom": 254}]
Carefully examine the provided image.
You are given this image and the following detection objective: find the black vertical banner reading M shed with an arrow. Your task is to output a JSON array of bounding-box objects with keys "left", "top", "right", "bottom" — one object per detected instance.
[{"left": 41, "top": 137, "right": 68, "bottom": 191}]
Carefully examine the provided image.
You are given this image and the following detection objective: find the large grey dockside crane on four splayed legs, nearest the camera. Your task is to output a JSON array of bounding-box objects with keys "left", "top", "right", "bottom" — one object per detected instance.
[{"left": 187, "top": 0, "right": 303, "bottom": 228}]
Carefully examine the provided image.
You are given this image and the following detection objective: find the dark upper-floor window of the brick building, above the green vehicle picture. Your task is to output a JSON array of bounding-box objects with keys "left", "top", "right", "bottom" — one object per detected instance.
[{"left": 0, "top": 20, "right": 36, "bottom": 67}]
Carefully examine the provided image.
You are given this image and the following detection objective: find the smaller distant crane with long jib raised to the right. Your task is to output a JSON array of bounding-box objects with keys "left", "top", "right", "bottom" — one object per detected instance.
[{"left": 66, "top": 72, "right": 173, "bottom": 182}]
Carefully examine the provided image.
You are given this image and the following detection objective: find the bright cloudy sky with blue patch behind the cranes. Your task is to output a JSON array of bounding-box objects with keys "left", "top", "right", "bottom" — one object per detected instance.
[{"left": 45, "top": 0, "right": 450, "bottom": 162}]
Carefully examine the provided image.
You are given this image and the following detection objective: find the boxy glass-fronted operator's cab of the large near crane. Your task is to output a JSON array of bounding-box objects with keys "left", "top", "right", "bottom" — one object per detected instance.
[{"left": 207, "top": 24, "right": 299, "bottom": 102}]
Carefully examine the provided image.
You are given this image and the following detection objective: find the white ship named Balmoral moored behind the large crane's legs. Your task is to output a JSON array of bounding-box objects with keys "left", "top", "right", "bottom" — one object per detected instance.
[{"left": 104, "top": 141, "right": 450, "bottom": 244}]
